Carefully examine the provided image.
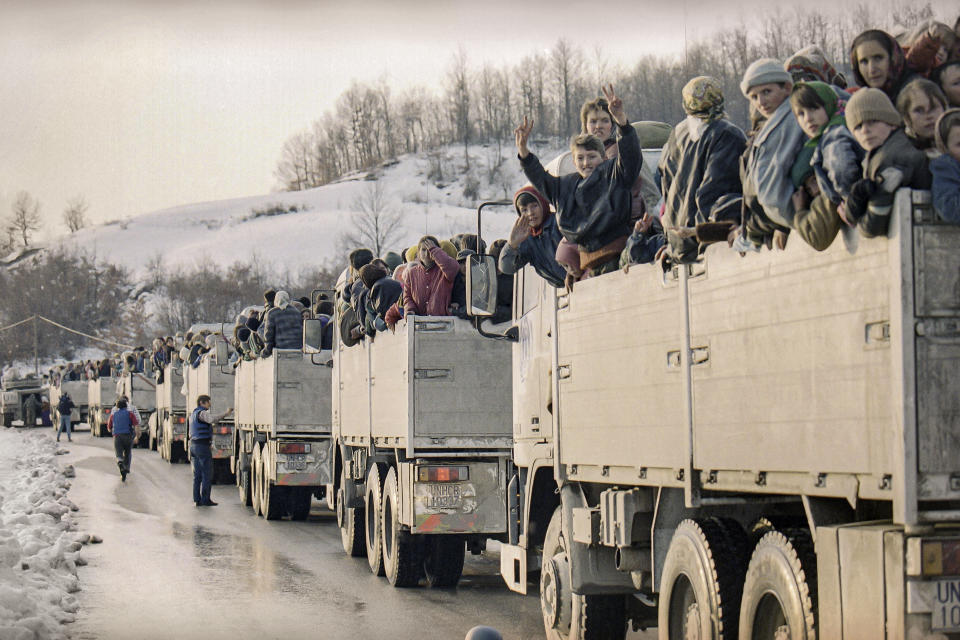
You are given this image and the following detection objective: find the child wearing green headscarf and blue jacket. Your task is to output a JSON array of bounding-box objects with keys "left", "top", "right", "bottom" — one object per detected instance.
[{"left": 790, "top": 82, "right": 864, "bottom": 251}]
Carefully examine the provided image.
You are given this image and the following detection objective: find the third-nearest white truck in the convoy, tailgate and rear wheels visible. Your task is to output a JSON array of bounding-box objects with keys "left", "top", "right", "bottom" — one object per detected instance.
[{"left": 230, "top": 349, "right": 333, "bottom": 520}]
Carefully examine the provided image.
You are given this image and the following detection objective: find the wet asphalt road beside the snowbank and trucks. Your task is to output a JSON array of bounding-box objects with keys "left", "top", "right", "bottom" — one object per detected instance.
[{"left": 62, "top": 432, "right": 543, "bottom": 640}]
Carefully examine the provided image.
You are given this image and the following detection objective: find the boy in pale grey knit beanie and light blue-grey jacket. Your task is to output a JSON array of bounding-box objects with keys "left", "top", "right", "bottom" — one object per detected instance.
[{"left": 735, "top": 58, "right": 804, "bottom": 249}]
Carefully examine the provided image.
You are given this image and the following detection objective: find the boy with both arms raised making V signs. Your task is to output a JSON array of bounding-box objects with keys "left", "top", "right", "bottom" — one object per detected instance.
[{"left": 514, "top": 86, "right": 643, "bottom": 275}]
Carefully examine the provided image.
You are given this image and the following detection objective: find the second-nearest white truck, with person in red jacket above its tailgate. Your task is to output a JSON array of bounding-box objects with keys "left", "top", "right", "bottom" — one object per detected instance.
[{"left": 320, "top": 316, "right": 513, "bottom": 587}]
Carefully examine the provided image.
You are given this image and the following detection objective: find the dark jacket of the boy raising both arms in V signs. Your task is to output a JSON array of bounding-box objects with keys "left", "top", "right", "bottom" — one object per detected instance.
[{"left": 520, "top": 124, "right": 643, "bottom": 252}]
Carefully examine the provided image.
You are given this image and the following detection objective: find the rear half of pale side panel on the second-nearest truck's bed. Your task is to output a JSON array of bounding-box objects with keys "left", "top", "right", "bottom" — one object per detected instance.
[{"left": 370, "top": 320, "right": 413, "bottom": 439}]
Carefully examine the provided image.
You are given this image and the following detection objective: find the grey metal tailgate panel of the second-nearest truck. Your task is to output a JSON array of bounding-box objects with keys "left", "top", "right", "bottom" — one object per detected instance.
[{"left": 414, "top": 317, "right": 513, "bottom": 446}]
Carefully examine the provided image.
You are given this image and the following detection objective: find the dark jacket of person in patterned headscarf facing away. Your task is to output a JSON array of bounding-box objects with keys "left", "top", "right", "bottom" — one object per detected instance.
[{"left": 658, "top": 118, "right": 747, "bottom": 260}]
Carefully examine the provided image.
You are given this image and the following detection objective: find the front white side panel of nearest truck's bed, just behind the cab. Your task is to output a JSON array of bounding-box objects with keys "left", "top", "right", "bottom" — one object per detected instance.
[{"left": 557, "top": 265, "right": 686, "bottom": 468}]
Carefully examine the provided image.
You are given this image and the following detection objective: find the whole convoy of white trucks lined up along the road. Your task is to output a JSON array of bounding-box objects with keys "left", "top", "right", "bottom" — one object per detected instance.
[{"left": 24, "top": 189, "right": 960, "bottom": 640}]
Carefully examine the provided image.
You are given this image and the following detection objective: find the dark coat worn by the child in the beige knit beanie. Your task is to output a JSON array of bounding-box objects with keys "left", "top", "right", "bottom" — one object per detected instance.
[{"left": 858, "top": 128, "right": 932, "bottom": 238}]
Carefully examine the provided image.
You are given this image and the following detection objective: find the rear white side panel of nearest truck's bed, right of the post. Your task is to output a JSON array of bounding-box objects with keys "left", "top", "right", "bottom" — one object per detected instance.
[{"left": 689, "top": 229, "right": 895, "bottom": 474}]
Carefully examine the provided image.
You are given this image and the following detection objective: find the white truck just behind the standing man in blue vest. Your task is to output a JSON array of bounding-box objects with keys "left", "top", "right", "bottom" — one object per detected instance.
[{"left": 182, "top": 350, "right": 236, "bottom": 482}]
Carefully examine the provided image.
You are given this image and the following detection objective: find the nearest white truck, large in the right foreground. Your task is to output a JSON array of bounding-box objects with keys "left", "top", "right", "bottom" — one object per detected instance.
[{"left": 470, "top": 189, "right": 960, "bottom": 640}]
